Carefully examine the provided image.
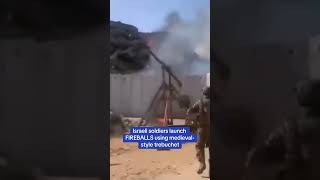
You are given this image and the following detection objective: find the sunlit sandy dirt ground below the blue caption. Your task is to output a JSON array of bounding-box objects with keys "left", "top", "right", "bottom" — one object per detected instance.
[{"left": 110, "top": 138, "right": 209, "bottom": 180}]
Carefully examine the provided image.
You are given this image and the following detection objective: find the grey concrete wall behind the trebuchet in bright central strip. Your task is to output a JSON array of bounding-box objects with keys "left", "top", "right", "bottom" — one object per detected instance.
[{"left": 110, "top": 74, "right": 206, "bottom": 117}]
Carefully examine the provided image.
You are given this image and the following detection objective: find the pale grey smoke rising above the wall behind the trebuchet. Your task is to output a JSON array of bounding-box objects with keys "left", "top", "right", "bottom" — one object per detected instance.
[{"left": 150, "top": 10, "right": 210, "bottom": 75}]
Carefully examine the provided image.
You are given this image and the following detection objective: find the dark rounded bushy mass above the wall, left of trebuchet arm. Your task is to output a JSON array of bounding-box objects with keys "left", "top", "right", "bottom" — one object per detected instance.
[{"left": 110, "top": 21, "right": 150, "bottom": 74}]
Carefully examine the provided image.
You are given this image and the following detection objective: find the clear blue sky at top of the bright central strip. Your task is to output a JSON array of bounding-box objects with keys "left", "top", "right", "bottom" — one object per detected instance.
[{"left": 110, "top": 0, "right": 210, "bottom": 32}]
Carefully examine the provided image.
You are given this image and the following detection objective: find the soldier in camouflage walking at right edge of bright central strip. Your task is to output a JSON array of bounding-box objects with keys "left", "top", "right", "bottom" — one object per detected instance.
[{"left": 187, "top": 87, "right": 210, "bottom": 174}]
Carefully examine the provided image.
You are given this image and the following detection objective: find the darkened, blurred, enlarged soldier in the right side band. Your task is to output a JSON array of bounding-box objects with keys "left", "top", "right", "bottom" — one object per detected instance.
[{"left": 246, "top": 81, "right": 320, "bottom": 180}]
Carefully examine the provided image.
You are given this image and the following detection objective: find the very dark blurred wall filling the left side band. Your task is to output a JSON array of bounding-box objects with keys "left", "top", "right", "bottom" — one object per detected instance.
[{"left": 0, "top": 27, "right": 107, "bottom": 176}]
